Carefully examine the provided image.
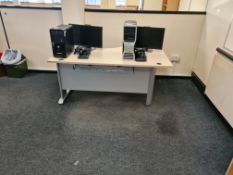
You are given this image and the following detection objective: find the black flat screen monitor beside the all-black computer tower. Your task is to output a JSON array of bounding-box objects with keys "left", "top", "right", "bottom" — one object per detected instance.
[{"left": 71, "top": 24, "right": 103, "bottom": 48}]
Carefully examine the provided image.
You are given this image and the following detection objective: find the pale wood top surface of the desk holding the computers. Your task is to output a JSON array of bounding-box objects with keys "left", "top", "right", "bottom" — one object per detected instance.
[{"left": 48, "top": 47, "right": 172, "bottom": 68}]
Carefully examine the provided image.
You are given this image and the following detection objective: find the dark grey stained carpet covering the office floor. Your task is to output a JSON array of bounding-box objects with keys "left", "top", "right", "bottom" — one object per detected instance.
[{"left": 0, "top": 73, "right": 233, "bottom": 175}]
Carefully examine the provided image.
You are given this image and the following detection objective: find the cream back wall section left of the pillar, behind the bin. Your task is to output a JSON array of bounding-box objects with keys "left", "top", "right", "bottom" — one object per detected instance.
[{"left": 0, "top": 9, "right": 62, "bottom": 70}]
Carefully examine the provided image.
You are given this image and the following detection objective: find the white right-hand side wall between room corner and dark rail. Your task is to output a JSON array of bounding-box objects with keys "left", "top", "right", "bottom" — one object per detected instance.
[{"left": 193, "top": 0, "right": 233, "bottom": 84}]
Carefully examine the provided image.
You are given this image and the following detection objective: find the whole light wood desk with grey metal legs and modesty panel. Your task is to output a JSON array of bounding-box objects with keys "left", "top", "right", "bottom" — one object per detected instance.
[{"left": 48, "top": 47, "right": 172, "bottom": 105}]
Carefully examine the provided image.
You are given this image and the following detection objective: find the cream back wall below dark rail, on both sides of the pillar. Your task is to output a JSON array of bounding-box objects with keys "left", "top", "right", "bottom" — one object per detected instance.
[{"left": 0, "top": 9, "right": 205, "bottom": 76}]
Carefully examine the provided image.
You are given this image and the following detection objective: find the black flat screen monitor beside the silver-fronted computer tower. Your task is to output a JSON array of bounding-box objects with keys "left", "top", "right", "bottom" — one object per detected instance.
[{"left": 135, "top": 27, "right": 165, "bottom": 49}]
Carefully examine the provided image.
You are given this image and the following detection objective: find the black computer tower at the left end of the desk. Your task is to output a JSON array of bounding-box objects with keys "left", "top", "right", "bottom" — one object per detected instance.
[{"left": 50, "top": 25, "right": 74, "bottom": 58}]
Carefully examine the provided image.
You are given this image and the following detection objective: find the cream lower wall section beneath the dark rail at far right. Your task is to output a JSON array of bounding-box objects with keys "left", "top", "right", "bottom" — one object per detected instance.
[{"left": 205, "top": 54, "right": 233, "bottom": 127}]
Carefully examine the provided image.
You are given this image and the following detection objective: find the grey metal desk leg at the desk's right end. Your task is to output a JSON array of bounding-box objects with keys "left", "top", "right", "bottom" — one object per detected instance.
[{"left": 146, "top": 69, "right": 155, "bottom": 106}]
